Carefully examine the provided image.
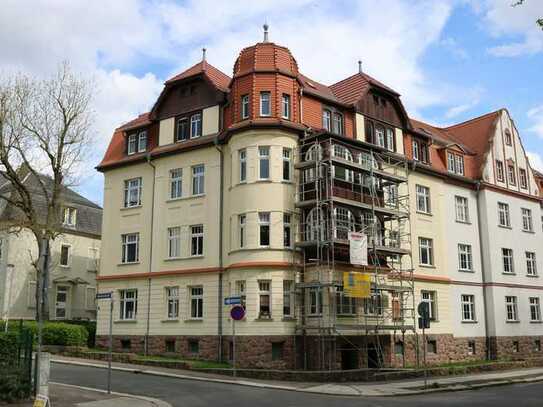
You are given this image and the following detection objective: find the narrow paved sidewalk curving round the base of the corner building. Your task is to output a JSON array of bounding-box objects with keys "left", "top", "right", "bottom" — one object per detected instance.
[{"left": 51, "top": 355, "right": 543, "bottom": 397}]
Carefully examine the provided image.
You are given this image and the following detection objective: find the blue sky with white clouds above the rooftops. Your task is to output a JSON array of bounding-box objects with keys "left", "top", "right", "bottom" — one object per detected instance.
[{"left": 0, "top": 0, "right": 543, "bottom": 203}]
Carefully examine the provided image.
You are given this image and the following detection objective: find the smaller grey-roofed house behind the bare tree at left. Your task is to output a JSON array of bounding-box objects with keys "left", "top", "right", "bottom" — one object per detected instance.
[{"left": 0, "top": 175, "right": 102, "bottom": 320}]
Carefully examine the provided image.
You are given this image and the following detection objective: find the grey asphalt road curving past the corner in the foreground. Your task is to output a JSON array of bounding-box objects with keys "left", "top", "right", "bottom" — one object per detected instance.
[{"left": 51, "top": 363, "right": 543, "bottom": 407}]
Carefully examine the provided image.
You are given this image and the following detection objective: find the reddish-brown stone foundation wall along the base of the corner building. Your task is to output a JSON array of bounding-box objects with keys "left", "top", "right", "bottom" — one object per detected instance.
[{"left": 96, "top": 334, "right": 543, "bottom": 370}]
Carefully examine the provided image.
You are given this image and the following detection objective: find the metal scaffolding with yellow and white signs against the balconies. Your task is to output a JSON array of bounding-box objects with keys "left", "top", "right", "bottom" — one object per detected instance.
[{"left": 296, "top": 133, "right": 415, "bottom": 370}]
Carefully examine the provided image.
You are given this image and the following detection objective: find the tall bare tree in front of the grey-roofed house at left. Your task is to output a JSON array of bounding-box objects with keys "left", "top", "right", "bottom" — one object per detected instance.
[{"left": 0, "top": 63, "right": 92, "bottom": 320}]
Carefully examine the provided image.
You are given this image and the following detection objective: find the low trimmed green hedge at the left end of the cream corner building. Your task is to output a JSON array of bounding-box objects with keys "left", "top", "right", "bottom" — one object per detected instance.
[{"left": 0, "top": 321, "right": 89, "bottom": 346}]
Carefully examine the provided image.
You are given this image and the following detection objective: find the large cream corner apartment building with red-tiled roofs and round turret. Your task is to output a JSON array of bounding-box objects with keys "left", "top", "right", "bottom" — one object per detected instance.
[{"left": 98, "top": 31, "right": 543, "bottom": 369}]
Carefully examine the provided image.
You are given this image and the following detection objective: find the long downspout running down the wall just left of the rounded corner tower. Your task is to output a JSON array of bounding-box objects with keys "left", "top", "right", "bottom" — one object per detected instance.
[{"left": 214, "top": 108, "right": 224, "bottom": 362}]
